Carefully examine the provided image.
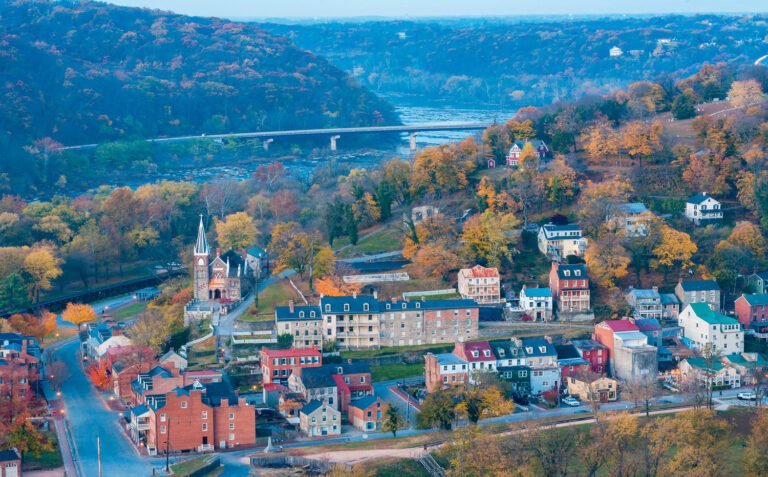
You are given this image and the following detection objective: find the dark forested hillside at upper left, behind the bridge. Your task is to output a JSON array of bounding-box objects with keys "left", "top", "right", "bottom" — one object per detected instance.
[{"left": 0, "top": 0, "right": 397, "bottom": 190}]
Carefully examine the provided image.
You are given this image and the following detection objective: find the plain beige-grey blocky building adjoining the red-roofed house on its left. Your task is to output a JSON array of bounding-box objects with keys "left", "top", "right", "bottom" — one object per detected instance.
[{"left": 611, "top": 331, "right": 659, "bottom": 381}]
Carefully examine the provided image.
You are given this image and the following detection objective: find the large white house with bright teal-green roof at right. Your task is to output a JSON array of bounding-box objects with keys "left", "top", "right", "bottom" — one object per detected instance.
[{"left": 678, "top": 303, "right": 744, "bottom": 354}]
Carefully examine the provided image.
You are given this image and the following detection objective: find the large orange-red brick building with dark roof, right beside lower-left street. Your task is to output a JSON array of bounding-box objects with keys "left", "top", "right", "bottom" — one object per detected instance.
[{"left": 134, "top": 381, "right": 256, "bottom": 455}]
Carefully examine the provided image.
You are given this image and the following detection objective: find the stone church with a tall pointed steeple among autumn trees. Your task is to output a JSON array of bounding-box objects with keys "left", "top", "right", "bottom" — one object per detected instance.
[{"left": 192, "top": 216, "right": 250, "bottom": 303}]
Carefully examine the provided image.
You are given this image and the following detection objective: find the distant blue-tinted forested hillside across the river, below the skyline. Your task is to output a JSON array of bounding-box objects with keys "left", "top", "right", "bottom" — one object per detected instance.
[{"left": 261, "top": 16, "right": 768, "bottom": 106}]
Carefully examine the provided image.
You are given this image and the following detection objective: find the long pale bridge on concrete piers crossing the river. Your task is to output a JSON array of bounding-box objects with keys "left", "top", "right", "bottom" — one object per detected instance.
[{"left": 63, "top": 121, "right": 490, "bottom": 151}]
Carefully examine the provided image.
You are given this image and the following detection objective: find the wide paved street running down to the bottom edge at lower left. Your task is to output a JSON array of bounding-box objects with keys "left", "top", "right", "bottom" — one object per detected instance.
[{"left": 55, "top": 340, "right": 152, "bottom": 477}]
